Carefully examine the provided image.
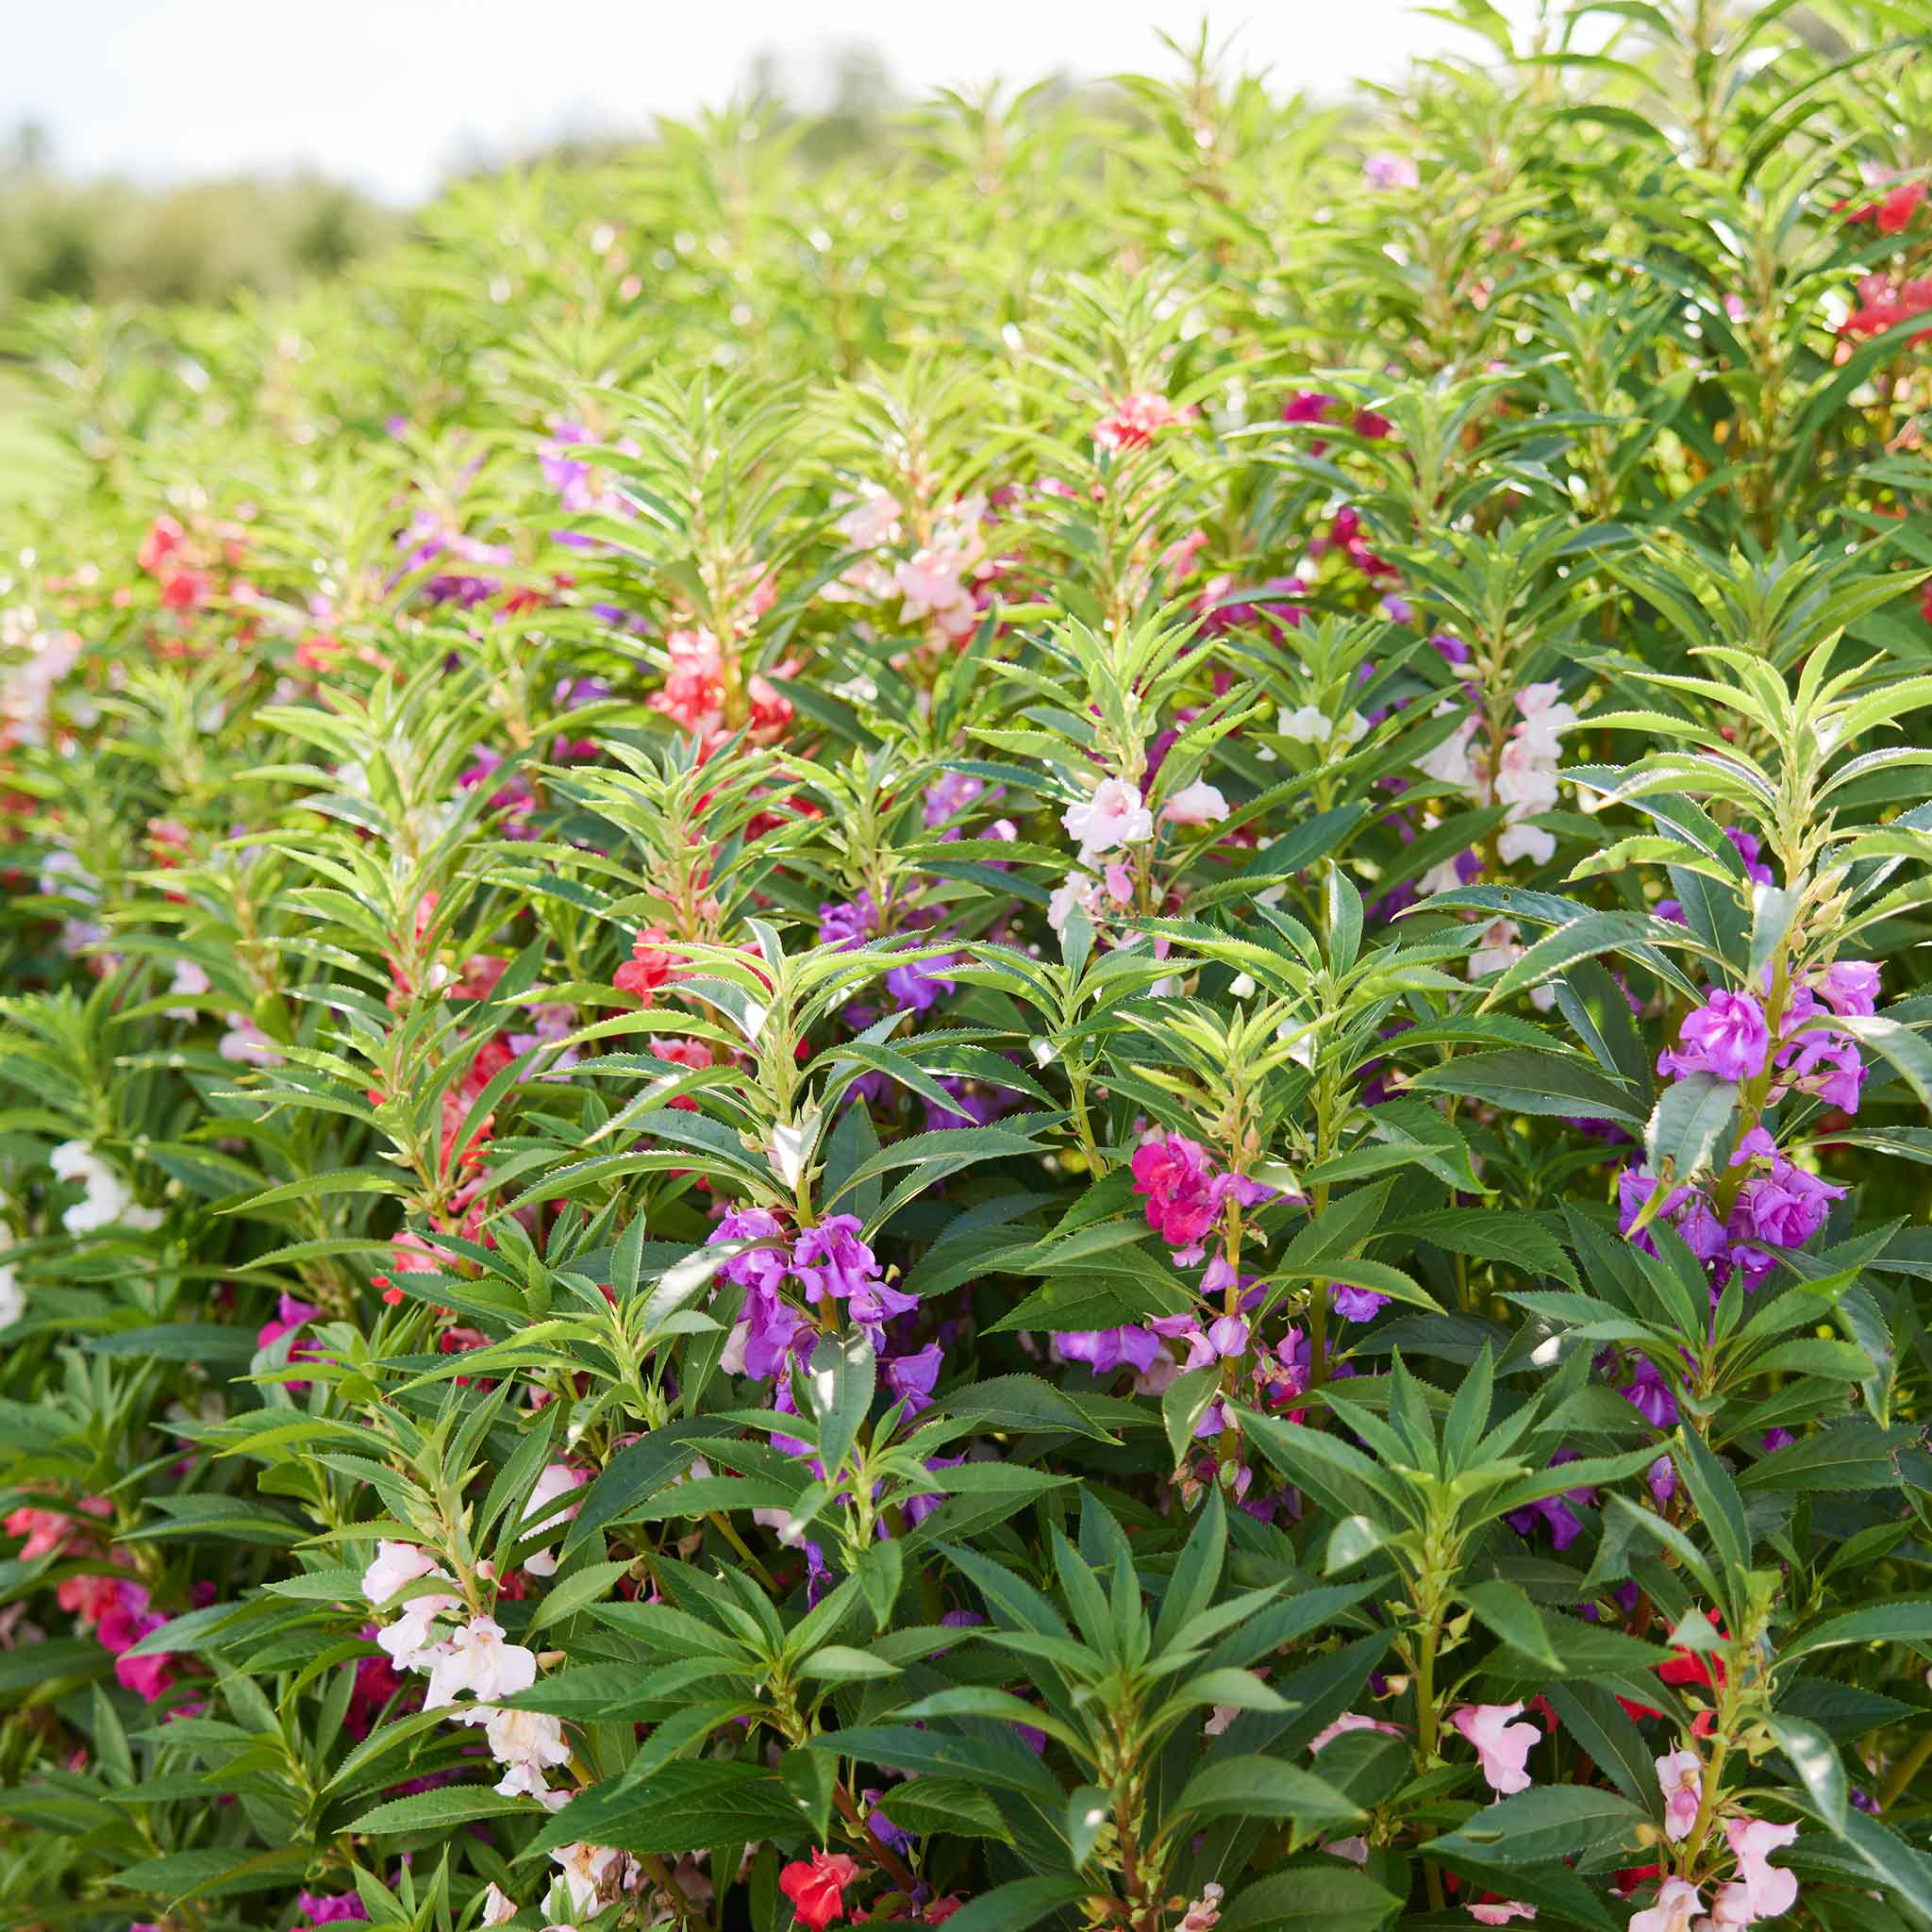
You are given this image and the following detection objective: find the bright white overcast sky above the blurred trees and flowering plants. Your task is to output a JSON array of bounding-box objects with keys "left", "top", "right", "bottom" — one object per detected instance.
[{"left": 0, "top": 0, "right": 1532, "bottom": 203}]
